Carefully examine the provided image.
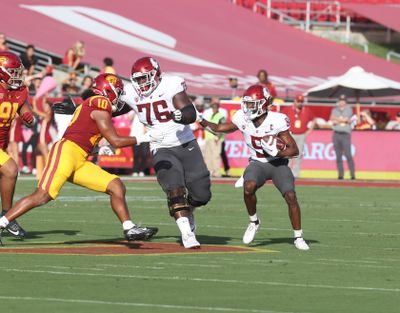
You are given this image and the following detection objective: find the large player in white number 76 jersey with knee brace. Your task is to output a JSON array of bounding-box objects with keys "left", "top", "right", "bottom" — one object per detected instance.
[{"left": 122, "top": 57, "right": 211, "bottom": 248}]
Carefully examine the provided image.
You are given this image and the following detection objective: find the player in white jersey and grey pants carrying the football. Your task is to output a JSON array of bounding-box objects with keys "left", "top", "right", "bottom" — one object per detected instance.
[{"left": 200, "top": 85, "right": 309, "bottom": 250}]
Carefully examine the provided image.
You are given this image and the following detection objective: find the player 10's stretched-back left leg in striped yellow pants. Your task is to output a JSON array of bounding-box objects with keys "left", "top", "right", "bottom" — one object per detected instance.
[{"left": 0, "top": 140, "right": 72, "bottom": 236}]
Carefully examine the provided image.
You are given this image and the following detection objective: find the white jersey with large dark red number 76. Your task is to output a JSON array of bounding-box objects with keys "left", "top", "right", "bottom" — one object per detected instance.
[{"left": 121, "top": 75, "right": 195, "bottom": 151}]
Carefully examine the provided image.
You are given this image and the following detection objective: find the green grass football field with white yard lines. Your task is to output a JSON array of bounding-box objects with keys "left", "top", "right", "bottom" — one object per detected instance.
[{"left": 0, "top": 180, "right": 400, "bottom": 313}]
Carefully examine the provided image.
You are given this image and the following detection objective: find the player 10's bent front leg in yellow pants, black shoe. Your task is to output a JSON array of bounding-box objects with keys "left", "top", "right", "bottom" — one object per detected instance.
[{"left": 70, "top": 161, "right": 158, "bottom": 241}]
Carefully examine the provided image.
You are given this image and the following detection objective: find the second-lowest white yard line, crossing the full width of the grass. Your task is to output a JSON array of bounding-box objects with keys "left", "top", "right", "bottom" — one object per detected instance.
[{"left": 0, "top": 267, "right": 400, "bottom": 293}]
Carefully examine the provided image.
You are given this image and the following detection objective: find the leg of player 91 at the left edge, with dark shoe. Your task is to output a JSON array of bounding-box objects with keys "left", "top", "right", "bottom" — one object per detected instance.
[{"left": 0, "top": 150, "right": 26, "bottom": 238}]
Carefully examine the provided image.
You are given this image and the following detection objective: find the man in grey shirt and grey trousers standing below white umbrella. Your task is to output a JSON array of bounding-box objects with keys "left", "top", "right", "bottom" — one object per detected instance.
[{"left": 330, "top": 95, "right": 356, "bottom": 179}]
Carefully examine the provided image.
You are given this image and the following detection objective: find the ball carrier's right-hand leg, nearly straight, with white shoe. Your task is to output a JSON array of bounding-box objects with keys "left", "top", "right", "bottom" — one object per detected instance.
[{"left": 271, "top": 159, "right": 309, "bottom": 250}]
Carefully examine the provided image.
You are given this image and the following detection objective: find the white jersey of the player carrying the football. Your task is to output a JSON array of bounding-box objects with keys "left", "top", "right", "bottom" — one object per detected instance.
[{"left": 232, "top": 110, "right": 290, "bottom": 163}]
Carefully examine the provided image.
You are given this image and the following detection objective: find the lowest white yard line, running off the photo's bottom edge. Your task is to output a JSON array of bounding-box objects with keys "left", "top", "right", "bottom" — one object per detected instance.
[{"left": 0, "top": 295, "right": 305, "bottom": 313}]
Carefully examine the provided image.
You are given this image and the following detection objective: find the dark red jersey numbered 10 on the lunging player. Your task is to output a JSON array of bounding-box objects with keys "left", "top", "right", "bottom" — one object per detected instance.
[{"left": 63, "top": 96, "right": 112, "bottom": 154}]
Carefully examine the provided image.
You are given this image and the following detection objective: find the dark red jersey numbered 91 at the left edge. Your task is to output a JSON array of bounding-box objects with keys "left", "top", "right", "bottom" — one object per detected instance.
[{"left": 0, "top": 85, "right": 28, "bottom": 150}]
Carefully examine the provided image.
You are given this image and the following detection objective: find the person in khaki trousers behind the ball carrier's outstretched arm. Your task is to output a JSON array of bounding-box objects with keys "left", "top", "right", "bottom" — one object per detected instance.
[{"left": 203, "top": 97, "right": 226, "bottom": 177}]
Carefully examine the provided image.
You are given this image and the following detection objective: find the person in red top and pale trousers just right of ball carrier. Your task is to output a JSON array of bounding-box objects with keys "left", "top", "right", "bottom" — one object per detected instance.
[{"left": 284, "top": 95, "right": 316, "bottom": 178}]
